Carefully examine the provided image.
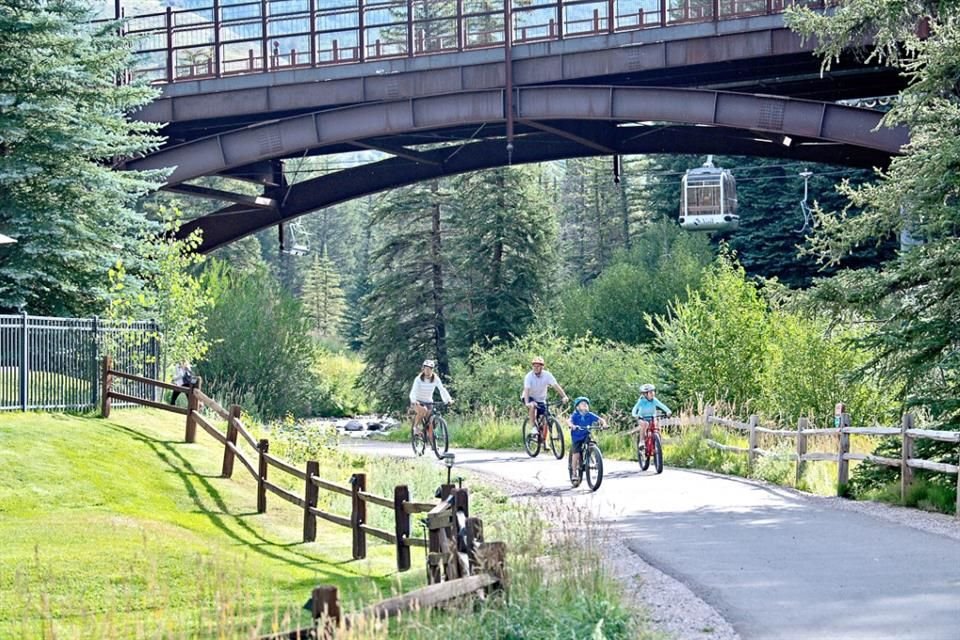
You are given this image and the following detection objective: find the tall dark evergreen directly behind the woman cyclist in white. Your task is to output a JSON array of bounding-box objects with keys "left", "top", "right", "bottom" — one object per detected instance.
[{"left": 363, "top": 181, "right": 450, "bottom": 408}]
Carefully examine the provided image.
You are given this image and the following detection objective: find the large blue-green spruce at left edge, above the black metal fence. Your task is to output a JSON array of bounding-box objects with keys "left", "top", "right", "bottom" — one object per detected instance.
[{"left": 0, "top": 0, "right": 160, "bottom": 315}]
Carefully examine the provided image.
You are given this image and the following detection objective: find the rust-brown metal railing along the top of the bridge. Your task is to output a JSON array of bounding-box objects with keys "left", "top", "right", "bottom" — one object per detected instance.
[{"left": 97, "top": 0, "right": 824, "bottom": 83}]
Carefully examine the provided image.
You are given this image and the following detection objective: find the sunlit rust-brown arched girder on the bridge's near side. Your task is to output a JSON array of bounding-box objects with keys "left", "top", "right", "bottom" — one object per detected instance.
[{"left": 127, "top": 86, "right": 908, "bottom": 185}]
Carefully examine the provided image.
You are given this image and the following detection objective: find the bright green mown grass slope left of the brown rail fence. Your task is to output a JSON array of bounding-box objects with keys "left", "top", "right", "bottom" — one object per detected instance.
[{"left": 0, "top": 410, "right": 438, "bottom": 638}]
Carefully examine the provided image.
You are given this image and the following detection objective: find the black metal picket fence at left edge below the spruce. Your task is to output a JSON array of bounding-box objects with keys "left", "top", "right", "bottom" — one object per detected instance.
[{"left": 0, "top": 313, "right": 163, "bottom": 411}]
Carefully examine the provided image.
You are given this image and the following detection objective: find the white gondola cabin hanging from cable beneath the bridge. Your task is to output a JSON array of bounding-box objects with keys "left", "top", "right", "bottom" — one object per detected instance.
[{"left": 680, "top": 157, "right": 740, "bottom": 231}]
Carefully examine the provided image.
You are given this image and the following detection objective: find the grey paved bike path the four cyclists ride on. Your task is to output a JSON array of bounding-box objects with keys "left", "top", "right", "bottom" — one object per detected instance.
[{"left": 351, "top": 442, "right": 960, "bottom": 640}]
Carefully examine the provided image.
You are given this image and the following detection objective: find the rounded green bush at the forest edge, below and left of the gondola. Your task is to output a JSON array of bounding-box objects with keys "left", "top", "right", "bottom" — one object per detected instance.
[{"left": 557, "top": 223, "right": 713, "bottom": 344}]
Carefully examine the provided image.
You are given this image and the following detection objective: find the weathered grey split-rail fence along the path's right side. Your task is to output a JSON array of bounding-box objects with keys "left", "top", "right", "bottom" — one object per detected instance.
[{"left": 692, "top": 404, "right": 960, "bottom": 518}]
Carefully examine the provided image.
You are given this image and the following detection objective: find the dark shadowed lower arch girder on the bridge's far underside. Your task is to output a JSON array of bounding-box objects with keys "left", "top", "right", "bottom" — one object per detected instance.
[{"left": 178, "top": 123, "right": 890, "bottom": 253}]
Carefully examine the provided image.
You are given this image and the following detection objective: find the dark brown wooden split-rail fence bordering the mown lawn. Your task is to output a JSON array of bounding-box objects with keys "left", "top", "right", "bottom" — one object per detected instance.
[{"left": 101, "top": 358, "right": 479, "bottom": 576}]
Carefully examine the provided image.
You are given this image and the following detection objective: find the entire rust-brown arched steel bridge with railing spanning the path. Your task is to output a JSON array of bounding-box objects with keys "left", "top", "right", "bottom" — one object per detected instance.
[{"left": 115, "top": 0, "right": 908, "bottom": 251}]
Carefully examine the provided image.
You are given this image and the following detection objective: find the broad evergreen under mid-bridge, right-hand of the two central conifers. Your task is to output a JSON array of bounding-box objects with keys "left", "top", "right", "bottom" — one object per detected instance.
[{"left": 451, "top": 167, "right": 557, "bottom": 355}]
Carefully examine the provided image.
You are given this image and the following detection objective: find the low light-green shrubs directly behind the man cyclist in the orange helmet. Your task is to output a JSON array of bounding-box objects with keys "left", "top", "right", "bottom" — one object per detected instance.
[{"left": 454, "top": 331, "right": 654, "bottom": 418}]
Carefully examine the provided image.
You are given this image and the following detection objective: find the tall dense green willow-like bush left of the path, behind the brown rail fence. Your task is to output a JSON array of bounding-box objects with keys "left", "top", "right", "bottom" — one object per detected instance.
[{"left": 195, "top": 261, "right": 317, "bottom": 419}]
